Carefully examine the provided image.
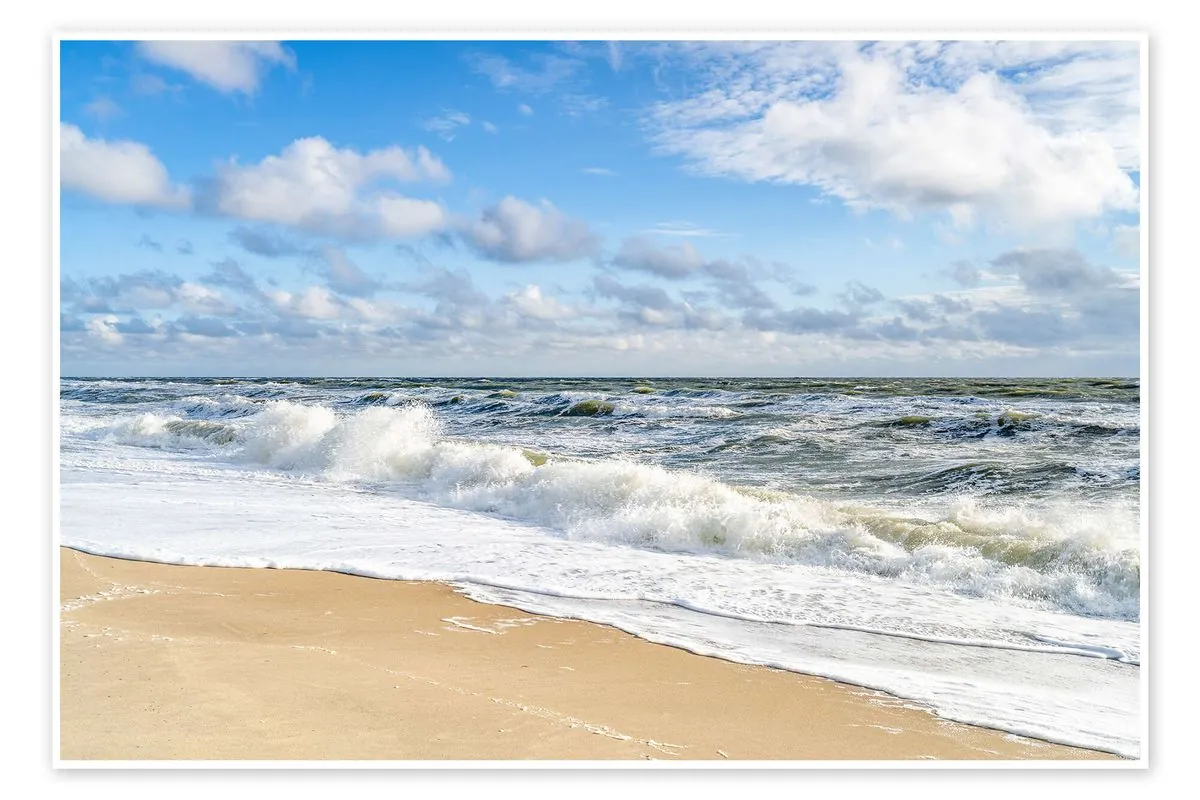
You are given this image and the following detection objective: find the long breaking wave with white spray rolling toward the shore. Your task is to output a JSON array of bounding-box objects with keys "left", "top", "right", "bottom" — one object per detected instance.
[{"left": 88, "top": 401, "right": 1140, "bottom": 619}]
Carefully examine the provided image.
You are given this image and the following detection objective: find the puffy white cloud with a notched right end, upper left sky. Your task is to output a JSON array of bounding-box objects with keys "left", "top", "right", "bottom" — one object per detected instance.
[{"left": 204, "top": 137, "right": 450, "bottom": 239}]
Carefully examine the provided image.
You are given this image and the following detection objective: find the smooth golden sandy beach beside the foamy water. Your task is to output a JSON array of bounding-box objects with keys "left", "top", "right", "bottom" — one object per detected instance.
[{"left": 60, "top": 548, "right": 1109, "bottom": 760}]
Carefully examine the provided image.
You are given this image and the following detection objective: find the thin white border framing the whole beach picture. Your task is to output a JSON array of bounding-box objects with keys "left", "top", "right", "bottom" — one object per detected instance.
[{"left": 49, "top": 24, "right": 1151, "bottom": 771}]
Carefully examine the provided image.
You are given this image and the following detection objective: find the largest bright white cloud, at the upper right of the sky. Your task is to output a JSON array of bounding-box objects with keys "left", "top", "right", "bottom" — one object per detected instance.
[{"left": 650, "top": 43, "right": 1138, "bottom": 228}]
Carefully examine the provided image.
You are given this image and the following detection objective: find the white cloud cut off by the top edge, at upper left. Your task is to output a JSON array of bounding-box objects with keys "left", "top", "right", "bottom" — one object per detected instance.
[{"left": 137, "top": 41, "right": 296, "bottom": 95}]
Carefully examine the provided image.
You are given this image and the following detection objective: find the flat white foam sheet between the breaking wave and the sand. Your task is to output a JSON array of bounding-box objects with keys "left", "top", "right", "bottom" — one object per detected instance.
[{"left": 61, "top": 450, "right": 1139, "bottom": 756}]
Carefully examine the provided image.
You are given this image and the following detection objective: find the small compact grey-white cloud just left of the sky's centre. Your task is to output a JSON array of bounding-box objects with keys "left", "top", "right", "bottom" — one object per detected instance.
[{"left": 458, "top": 196, "right": 599, "bottom": 263}]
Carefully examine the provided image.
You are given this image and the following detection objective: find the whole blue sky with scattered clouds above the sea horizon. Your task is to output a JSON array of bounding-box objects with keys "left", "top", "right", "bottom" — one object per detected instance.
[{"left": 58, "top": 41, "right": 1141, "bottom": 377}]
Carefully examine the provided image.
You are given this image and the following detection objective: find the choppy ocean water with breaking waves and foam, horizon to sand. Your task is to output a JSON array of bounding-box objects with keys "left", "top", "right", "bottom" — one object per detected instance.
[{"left": 60, "top": 378, "right": 1141, "bottom": 757}]
